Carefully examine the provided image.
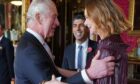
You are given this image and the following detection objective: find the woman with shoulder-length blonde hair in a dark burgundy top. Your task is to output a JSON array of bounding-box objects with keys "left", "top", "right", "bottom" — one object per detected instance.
[{"left": 85, "top": 0, "right": 130, "bottom": 84}]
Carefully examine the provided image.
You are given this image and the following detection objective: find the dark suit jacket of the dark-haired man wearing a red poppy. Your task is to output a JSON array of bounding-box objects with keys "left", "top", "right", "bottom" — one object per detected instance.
[{"left": 62, "top": 40, "right": 97, "bottom": 70}]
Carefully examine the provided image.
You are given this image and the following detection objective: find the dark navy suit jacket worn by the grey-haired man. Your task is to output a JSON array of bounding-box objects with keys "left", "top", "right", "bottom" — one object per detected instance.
[{"left": 15, "top": 32, "right": 87, "bottom": 84}]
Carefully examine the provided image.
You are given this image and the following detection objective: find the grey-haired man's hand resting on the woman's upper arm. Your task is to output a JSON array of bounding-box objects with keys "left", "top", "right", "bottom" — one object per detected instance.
[{"left": 87, "top": 51, "right": 115, "bottom": 79}]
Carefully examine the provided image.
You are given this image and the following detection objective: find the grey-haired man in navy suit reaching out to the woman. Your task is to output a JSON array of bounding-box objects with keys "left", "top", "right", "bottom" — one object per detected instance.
[{"left": 14, "top": 0, "right": 115, "bottom": 84}]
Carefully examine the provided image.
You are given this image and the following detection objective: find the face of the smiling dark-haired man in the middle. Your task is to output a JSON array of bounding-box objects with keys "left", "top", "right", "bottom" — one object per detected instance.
[{"left": 72, "top": 19, "right": 89, "bottom": 42}]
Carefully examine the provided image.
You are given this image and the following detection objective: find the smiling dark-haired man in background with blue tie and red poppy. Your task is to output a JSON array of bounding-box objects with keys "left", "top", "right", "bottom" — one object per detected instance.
[{"left": 62, "top": 12, "right": 97, "bottom": 70}]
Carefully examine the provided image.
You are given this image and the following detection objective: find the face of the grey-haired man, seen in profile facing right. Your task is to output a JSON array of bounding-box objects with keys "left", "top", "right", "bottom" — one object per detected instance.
[{"left": 42, "top": 2, "right": 59, "bottom": 38}]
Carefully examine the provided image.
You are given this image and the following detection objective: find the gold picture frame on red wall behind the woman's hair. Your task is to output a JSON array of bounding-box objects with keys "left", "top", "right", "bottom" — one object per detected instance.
[{"left": 128, "top": 0, "right": 140, "bottom": 35}]
